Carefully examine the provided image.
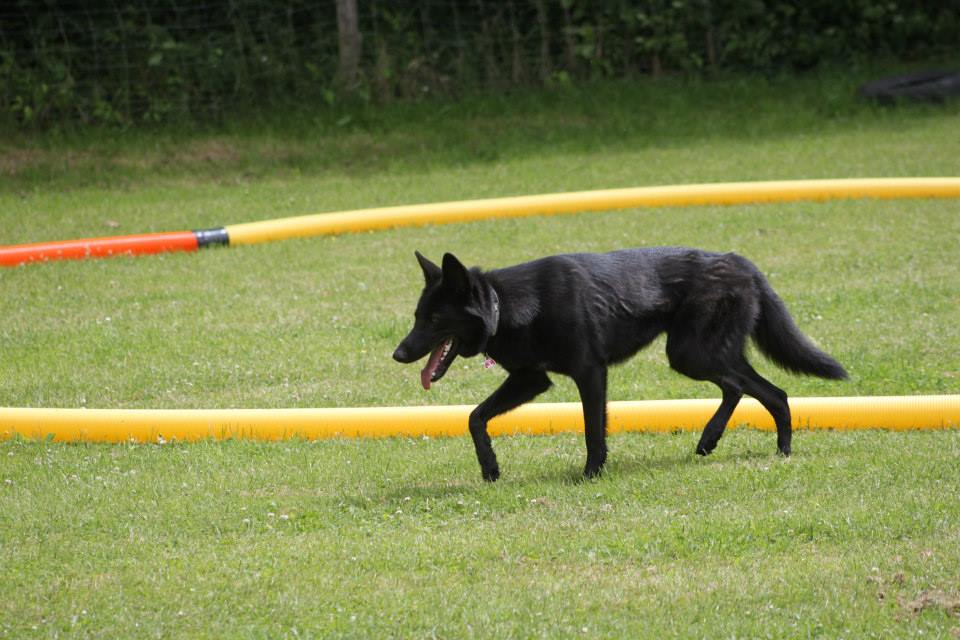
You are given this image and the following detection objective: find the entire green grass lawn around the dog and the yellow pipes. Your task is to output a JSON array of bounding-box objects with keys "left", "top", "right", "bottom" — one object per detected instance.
[{"left": 0, "top": 71, "right": 960, "bottom": 638}]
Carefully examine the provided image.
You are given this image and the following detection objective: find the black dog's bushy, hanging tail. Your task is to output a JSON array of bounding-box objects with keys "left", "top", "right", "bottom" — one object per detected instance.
[{"left": 753, "top": 273, "right": 847, "bottom": 380}]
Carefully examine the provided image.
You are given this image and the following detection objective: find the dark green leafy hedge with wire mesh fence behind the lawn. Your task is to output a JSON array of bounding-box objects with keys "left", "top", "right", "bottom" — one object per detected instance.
[{"left": 0, "top": 0, "right": 960, "bottom": 126}]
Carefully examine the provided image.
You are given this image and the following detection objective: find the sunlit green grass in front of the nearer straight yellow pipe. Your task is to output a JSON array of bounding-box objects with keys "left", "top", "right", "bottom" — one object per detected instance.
[{"left": 0, "top": 430, "right": 960, "bottom": 638}]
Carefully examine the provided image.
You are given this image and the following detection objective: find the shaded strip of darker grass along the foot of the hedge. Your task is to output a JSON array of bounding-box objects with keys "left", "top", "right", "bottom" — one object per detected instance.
[{"left": 7, "top": 70, "right": 955, "bottom": 189}]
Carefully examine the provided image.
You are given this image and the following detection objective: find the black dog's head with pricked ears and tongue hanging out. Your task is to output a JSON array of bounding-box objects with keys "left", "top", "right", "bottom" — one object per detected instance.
[{"left": 393, "top": 251, "right": 500, "bottom": 389}]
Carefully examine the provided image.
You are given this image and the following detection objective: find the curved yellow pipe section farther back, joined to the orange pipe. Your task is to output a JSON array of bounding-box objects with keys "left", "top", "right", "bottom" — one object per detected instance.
[{"left": 225, "top": 178, "right": 960, "bottom": 245}]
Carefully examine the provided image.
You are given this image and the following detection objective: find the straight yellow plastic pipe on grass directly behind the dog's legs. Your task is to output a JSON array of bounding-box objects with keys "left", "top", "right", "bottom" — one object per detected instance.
[{"left": 0, "top": 395, "right": 960, "bottom": 442}]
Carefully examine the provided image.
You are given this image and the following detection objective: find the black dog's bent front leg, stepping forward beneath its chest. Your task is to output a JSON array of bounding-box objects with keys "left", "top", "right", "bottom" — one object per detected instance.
[{"left": 470, "top": 371, "right": 551, "bottom": 482}]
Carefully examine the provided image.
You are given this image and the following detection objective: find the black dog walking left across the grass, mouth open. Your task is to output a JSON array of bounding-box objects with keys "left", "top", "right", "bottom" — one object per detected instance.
[{"left": 393, "top": 247, "right": 847, "bottom": 481}]
